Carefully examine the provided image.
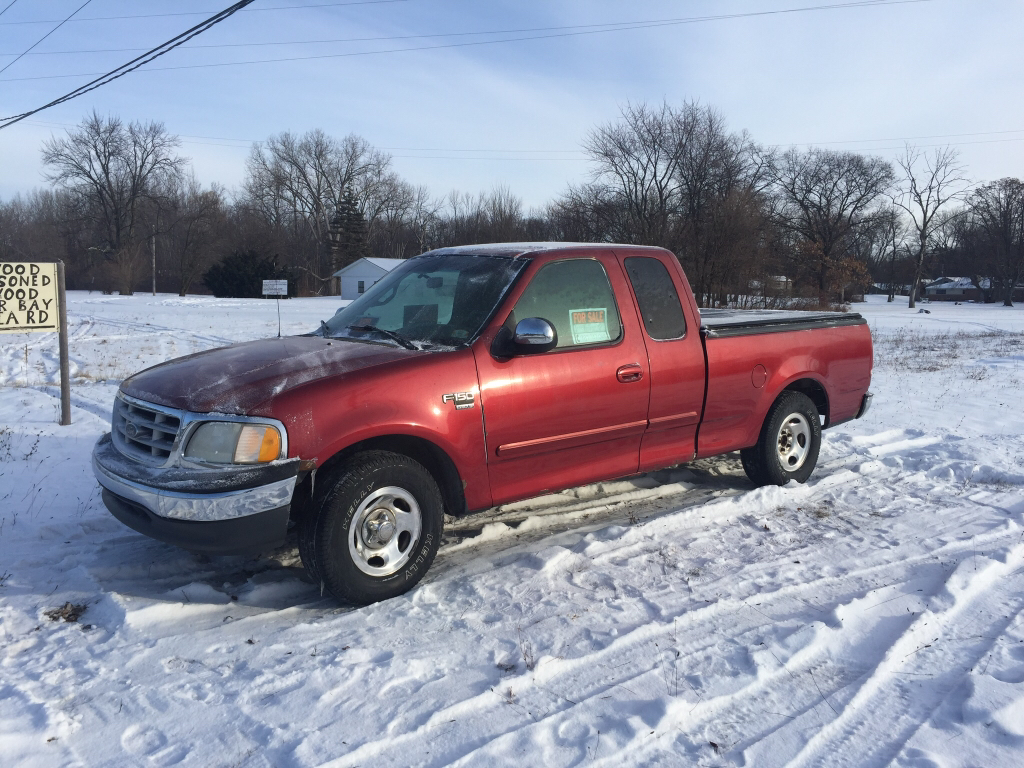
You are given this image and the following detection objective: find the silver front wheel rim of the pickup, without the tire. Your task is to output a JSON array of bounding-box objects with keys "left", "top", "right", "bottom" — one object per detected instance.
[{"left": 348, "top": 485, "right": 423, "bottom": 577}]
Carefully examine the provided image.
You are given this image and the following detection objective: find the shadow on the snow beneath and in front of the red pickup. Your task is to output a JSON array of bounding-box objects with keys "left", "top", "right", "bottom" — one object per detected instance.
[{"left": 79, "top": 455, "right": 753, "bottom": 614}]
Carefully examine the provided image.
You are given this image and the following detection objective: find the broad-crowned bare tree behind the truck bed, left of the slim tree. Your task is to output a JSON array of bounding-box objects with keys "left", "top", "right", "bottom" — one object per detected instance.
[{"left": 771, "top": 148, "right": 895, "bottom": 298}]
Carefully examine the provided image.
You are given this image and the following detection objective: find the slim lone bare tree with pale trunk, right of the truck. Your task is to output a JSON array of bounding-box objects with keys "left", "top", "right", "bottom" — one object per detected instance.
[{"left": 893, "top": 144, "right": 968, "bottom": 309}]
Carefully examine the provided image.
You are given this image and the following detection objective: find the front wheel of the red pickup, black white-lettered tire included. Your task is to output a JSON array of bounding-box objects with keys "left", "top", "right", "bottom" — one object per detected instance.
[{"left": 298, "top": 451, "right": 444, "bottom": 605}]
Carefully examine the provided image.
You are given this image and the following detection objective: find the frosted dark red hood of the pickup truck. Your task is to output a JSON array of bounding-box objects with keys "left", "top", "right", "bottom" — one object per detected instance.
[{"left": 121, "top": 336, "right": 419, "bottom": 415}]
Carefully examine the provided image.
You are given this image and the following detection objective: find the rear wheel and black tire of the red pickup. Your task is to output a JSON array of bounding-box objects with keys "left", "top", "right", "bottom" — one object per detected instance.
[{"left": 739, "top": 392, "right": 821, "bottom": 485}]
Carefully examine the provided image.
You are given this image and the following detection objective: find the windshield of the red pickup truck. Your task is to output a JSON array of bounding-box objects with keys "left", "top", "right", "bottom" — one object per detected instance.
[{"left": 317, "top": 255, "right": 526, "bottom": 348}]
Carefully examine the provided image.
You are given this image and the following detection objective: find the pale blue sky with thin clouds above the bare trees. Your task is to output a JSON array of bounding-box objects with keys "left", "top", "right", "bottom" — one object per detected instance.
[{"left": 0, "top": 0, "right": 1024, "bottom": 206}]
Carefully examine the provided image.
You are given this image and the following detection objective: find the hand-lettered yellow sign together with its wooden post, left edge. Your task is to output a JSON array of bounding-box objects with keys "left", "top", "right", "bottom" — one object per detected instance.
[{"left": 0, "top": 261, "right": 71, "bottom": 426}]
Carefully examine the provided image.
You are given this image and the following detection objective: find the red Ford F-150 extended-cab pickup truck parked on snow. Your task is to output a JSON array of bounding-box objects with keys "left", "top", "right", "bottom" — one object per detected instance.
[{"left": 93, "top": 243, "right": 871, "bottom": 603}]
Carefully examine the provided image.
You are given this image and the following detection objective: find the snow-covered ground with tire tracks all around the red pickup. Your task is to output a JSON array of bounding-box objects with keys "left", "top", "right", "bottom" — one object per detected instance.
[{"left": 0, "top": 293, "right": 1024, "bottom": 767}]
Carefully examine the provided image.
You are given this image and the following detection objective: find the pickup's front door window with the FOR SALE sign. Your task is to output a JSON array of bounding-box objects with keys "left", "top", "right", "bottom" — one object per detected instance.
[{"left": 509, "top": 259, "right": 623, "bottom": 349}]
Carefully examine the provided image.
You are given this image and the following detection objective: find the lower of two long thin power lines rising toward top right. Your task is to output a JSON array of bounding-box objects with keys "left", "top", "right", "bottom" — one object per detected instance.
[{"left": 0, "top": 0, "right": 935, "bottom": 83}]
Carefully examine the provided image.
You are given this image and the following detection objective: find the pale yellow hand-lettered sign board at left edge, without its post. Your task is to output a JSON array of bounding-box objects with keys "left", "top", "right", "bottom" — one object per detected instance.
[{"left": 0, "top": 261, "right": 59, "bottom": 333}]
